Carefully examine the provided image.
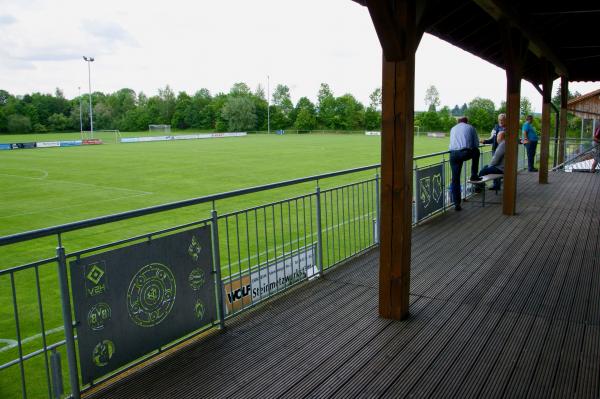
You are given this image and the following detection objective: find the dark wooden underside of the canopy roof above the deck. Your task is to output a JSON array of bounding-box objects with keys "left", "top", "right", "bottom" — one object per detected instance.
[{"left": 354, "top": 0, "right": 600, "bottom": 84}]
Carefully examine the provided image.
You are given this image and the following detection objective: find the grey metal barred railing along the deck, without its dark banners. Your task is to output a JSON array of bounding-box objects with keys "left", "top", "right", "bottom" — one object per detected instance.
[{"left": 0, "top": 145, "right": 526, "bottom": 397}]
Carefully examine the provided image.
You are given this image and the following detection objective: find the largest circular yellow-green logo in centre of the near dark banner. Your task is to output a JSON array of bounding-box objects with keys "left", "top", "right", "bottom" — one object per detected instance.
[{"left": 127, "top": 263, "right": 175, "bottom": 327}]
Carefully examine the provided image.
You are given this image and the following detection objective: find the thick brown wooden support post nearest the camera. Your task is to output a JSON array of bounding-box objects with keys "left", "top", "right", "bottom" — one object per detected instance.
[{"left": 368, "top": 0, "right": 421, "bottom": 320}]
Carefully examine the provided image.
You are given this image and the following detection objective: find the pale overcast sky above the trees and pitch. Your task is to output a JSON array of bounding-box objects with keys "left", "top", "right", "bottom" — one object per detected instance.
[{"left": 0, "top": 0, "right": 600, "bottom": 111}]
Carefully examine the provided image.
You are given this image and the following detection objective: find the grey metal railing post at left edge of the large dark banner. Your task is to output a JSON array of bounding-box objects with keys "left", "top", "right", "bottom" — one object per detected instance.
[{"left": 56, "top": 239, "right": 80, "bottom": 399}]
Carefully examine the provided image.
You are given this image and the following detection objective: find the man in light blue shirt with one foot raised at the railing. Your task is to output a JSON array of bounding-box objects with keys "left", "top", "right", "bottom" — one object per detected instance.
[{"left": 450, "top": 117, "right": 481, "bottom": 211}]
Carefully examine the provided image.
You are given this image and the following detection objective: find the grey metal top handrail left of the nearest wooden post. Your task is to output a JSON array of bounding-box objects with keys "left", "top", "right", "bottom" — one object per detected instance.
[{"left": 0, "top": 164, "right": 380, "bottom": 246}]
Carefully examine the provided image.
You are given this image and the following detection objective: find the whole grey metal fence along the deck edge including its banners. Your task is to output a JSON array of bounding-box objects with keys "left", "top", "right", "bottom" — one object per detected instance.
[{"left": 0, "top": 148, "right": 526, "bottom": 398}]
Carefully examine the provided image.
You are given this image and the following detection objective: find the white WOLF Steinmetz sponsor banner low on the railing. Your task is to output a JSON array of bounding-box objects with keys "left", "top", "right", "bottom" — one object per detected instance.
[{"left": 223, "top": 244, "right": 318, "bottom": 314}]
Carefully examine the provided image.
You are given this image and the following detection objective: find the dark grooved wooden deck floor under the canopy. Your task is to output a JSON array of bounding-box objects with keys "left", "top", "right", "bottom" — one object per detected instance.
[{"left": 90, "top": 173, "right": 600, "bottom": 398}]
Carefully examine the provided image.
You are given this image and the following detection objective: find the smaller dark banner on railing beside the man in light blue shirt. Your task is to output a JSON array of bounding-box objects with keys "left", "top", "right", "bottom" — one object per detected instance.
[{"left": 416, "top": 164, "right": 444, "bottom": 220}]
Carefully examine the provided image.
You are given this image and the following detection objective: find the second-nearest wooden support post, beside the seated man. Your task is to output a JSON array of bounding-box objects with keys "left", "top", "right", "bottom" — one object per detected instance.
[{"left": 499, "top": 25, "right": 527, "bottom": 216}]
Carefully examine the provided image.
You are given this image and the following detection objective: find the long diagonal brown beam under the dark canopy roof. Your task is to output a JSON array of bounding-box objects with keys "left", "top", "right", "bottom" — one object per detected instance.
[{"left": 473, "top": 0, "right": 568, "bottom": 76}]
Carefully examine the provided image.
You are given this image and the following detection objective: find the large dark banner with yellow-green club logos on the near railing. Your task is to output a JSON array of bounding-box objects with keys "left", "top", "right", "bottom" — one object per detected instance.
[{"left": 70, "top": 226, "right": 217, "bottom": 383}]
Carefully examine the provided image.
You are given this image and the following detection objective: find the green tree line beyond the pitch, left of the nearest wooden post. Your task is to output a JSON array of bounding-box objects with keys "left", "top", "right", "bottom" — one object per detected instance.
[{"left": 0, "top": 83, "right": 381, "bottom": 133}]
